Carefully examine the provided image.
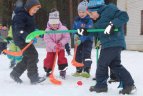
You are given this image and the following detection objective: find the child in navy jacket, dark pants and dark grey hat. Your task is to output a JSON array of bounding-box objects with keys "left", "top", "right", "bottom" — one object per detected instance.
[{"left": 10, "top": 0, "right": 45, "bottom": 84}]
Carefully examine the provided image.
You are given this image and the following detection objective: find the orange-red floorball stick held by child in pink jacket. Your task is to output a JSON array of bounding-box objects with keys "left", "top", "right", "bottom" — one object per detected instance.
[{"left": 49, "top": 49, "right": 62, "bottom": 85}]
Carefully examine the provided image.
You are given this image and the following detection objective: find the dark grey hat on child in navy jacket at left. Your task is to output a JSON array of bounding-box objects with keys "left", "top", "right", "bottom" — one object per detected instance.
[{"left": 24, "top": 0, "right": 41, "bottom": 11}]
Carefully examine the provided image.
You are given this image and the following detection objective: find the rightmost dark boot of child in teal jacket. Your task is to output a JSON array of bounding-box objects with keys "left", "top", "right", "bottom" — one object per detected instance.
[{"left": 119, "top": 85, "right": 136, "bottom": 94}]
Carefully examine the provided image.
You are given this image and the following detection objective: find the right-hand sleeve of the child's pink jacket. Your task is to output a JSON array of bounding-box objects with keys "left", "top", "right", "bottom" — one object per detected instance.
[{"left": 59, "top": 27, "right": 70, "bottom": 46}]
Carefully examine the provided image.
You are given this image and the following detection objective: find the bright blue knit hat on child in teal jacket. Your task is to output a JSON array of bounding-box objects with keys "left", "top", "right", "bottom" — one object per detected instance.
[{"left": 88, "top": 0, "right": 105, "bottom": 12}]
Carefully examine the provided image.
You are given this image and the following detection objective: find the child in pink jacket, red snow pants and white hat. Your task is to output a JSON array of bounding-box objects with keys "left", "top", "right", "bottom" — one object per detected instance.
[{"left": 44, "top": 10, "right": 70, "bottom": 78}]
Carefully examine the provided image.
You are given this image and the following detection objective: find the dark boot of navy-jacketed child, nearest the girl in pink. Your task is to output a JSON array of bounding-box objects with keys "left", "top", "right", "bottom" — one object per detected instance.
[{"left": 30, "top": 74, "right": 46, "bottom": 84}]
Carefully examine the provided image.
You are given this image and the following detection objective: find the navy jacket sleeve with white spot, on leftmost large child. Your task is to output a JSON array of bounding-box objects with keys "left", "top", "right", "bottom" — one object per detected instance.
[{"left": 13, "top": 14, "right": 28, "bottom": 40}]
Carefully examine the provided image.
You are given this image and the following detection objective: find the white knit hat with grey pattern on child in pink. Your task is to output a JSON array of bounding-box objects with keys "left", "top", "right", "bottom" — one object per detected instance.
[{"left": 49, "top": 11, "right": 60, "bottom": 24}]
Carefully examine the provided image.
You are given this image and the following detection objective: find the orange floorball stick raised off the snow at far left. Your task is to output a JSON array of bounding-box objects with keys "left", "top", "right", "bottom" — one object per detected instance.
[{"left": 3, "top": 41, "right": 33, "bottom": 56}]
